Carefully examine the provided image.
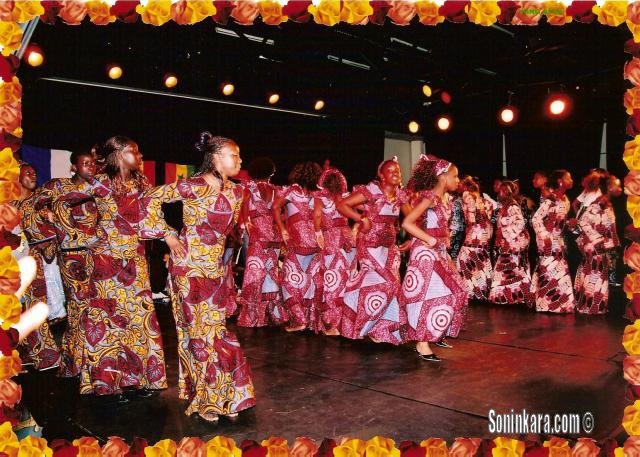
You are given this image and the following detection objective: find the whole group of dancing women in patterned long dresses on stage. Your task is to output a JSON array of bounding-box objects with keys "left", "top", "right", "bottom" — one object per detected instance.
[{"left": 14, "top": 132, "right": 618, "bottom": 422}]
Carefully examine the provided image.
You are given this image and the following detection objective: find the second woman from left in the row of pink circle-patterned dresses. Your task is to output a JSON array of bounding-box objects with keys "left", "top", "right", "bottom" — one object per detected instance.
[{"left": 272, "top": 162, "right": 324, "bottom": 332}]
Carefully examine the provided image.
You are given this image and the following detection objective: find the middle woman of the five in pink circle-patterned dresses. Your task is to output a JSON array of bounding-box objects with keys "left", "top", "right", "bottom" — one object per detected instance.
[{"left": 313, "top": 168, "right": 356, "bottom": 335}]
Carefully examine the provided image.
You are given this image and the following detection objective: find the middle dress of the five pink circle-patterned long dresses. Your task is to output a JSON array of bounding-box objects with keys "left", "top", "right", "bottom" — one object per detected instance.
[{"left": 314, "top": 190, "right": 356, "bottom": 330}]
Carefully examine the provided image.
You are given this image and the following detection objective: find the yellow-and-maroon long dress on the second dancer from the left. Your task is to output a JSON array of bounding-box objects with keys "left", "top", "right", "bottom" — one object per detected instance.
[{"left": 40, "top": 178, "right": 104, "bottom": 377}]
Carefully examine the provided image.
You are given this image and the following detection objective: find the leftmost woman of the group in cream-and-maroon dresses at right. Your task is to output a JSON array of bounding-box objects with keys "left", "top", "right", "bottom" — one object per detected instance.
[{"left": 457, "top": 176, "right": 493, "bottom": 300}]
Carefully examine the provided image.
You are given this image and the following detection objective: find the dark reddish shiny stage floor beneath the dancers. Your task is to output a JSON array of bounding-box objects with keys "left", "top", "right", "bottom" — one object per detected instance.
[{"left": 20, "top": 298, "right": 630, "bottom": 443}]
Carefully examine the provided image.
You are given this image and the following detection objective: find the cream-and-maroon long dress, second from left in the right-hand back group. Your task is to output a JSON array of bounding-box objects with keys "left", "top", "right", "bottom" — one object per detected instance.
[{"left": 489, "top": 202, "right": 531, "bottom": 305}]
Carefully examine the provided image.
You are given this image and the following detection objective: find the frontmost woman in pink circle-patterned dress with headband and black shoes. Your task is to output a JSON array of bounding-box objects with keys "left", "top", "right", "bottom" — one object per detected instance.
[{"left": 399, "top": 155, "right": 468, "bottom": 362}]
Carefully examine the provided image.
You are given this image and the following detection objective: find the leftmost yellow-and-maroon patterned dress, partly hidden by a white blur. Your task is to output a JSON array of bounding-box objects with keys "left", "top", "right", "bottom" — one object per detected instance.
[{"left": 12, "top": 192, "right": 60, "bottom": 370}]
